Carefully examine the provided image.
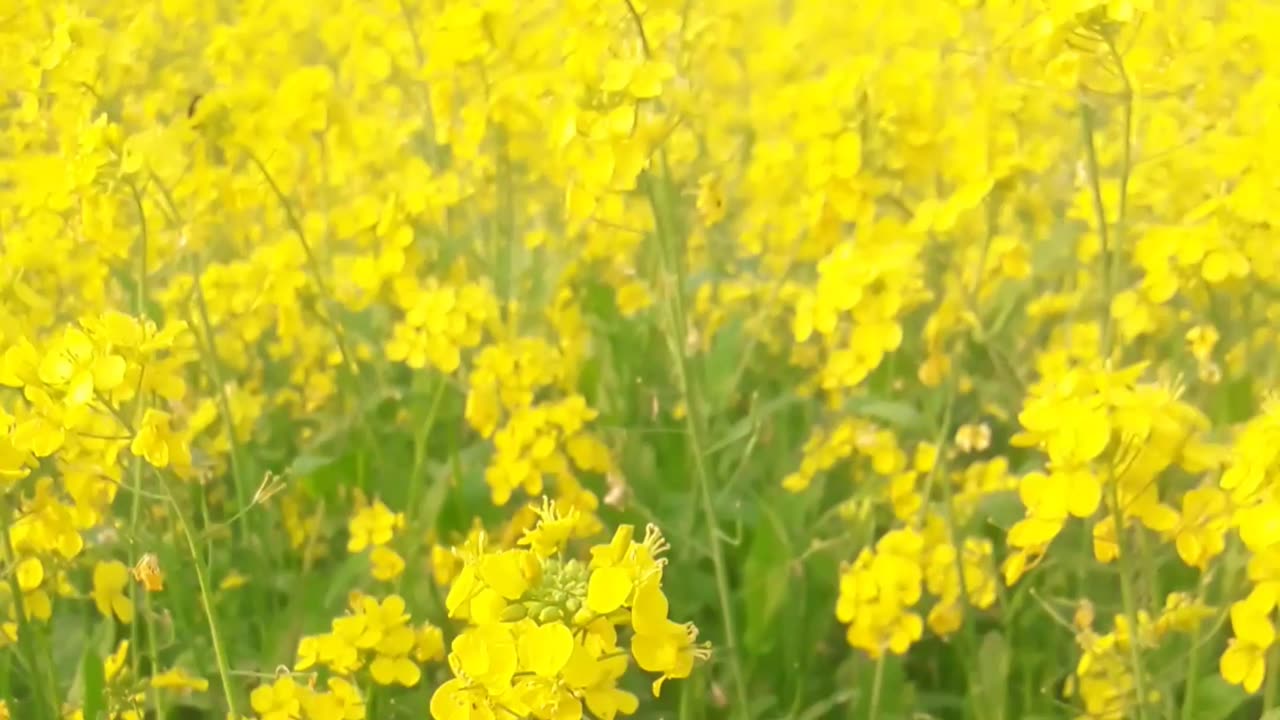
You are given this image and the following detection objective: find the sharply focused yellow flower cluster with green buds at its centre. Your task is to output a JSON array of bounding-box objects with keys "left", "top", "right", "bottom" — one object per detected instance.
[{"left": 431, "top": 502, "right": 708, "bottom": 720}]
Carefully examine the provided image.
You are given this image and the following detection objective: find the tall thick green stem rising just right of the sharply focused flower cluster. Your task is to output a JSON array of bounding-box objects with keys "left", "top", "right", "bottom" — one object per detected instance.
[{"left": 645, "top": 163, "right": 750, "bottom": 717}]
